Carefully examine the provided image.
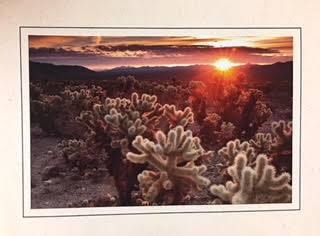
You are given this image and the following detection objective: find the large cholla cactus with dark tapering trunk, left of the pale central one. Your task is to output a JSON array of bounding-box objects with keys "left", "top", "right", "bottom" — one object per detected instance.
[{"left": 78, "top": 93, "right": 163, "bottom": 205}]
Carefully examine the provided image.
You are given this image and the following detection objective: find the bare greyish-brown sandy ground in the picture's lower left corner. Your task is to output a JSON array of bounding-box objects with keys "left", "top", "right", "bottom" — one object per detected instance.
[{"left": 31, "top": 137, "right": 117, "bottom": 208}]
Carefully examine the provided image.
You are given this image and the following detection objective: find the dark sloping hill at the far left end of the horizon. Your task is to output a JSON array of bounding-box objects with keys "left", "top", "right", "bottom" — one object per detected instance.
[{"left": 29, "top": 61, "right": 97, "bottom": 80}]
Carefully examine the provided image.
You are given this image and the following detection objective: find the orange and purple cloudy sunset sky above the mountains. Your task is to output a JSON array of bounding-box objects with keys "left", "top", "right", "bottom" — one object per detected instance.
[{"left": 29, "top": 36, "right": 293, "bottom": 70}]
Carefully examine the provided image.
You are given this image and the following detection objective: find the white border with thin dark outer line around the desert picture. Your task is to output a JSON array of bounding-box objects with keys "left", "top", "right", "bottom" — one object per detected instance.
[{"left": 19, "top": 26, "right": 302, "bottom": 217}]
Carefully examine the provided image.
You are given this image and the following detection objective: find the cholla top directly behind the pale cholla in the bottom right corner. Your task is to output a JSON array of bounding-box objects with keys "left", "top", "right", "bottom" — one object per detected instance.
[{"left": 218, "top": 139, "right": 256, "bottom": 165}]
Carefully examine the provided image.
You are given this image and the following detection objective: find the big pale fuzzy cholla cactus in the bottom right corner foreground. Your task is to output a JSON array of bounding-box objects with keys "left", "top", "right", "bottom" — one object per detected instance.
[{"left": 210, "top": 153, "right": 292, "bottom": 204}]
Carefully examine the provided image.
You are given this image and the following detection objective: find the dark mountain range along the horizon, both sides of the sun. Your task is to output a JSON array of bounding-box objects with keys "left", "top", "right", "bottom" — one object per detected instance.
[{"left": 30, "top": 61, "right": 293, "bottom": 81}]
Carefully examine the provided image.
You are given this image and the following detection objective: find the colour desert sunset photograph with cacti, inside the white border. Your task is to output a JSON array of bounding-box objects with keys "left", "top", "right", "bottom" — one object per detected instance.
[{"left": 22, "top": 29, "right": 300, "bottom": 210}]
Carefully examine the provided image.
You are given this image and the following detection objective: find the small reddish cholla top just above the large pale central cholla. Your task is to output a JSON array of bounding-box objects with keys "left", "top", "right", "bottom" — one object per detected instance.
[{"left": 163, "top": 104, "right": 194, "bottom": 128}]
